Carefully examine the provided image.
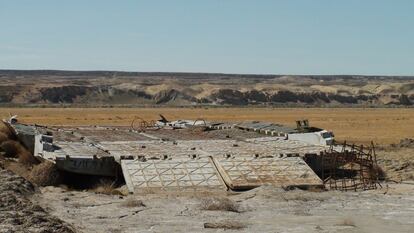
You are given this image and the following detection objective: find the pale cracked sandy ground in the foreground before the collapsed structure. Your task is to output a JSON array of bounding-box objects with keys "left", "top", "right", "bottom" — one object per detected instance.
[{"left": 35, "top": 183, "right": 414, "bottom": 232}]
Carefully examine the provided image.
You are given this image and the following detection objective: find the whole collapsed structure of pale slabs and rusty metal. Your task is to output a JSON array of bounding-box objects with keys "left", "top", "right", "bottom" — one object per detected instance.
[{"left": 1, "top": 115, "right": 378, "bottom": 193}]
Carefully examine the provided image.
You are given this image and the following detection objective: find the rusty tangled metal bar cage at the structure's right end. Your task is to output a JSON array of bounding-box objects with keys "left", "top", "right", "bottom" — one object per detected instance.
[{"left": 322, "top": 142, "right": 379, "bottom": 191}]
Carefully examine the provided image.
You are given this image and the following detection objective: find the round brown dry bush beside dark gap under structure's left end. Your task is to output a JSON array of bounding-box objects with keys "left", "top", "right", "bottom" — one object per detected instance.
[{"left": 27, "top": 161, "right": 62, "bottom": 186}]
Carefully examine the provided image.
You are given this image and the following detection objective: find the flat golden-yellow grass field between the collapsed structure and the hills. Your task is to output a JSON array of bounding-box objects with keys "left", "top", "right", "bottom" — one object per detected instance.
[{"left": 0, "top": 108, "right": 414, "bottom": 144}]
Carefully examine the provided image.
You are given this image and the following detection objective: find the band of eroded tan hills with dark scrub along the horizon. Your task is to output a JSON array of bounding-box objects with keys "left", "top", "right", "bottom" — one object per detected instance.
[{"left": 0, "top": 70, "right": 414, "bottom": 107}]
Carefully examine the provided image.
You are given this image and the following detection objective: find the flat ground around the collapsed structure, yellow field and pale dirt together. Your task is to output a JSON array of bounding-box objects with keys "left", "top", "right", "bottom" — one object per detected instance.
[{"left": 0, "top": 108, "right": 414, "bottom": 232}]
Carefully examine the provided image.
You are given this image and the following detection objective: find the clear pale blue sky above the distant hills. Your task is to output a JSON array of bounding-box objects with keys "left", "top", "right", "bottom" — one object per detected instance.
[{"left": 0, "top": 0, "right": 414, "bottom": 75}]
